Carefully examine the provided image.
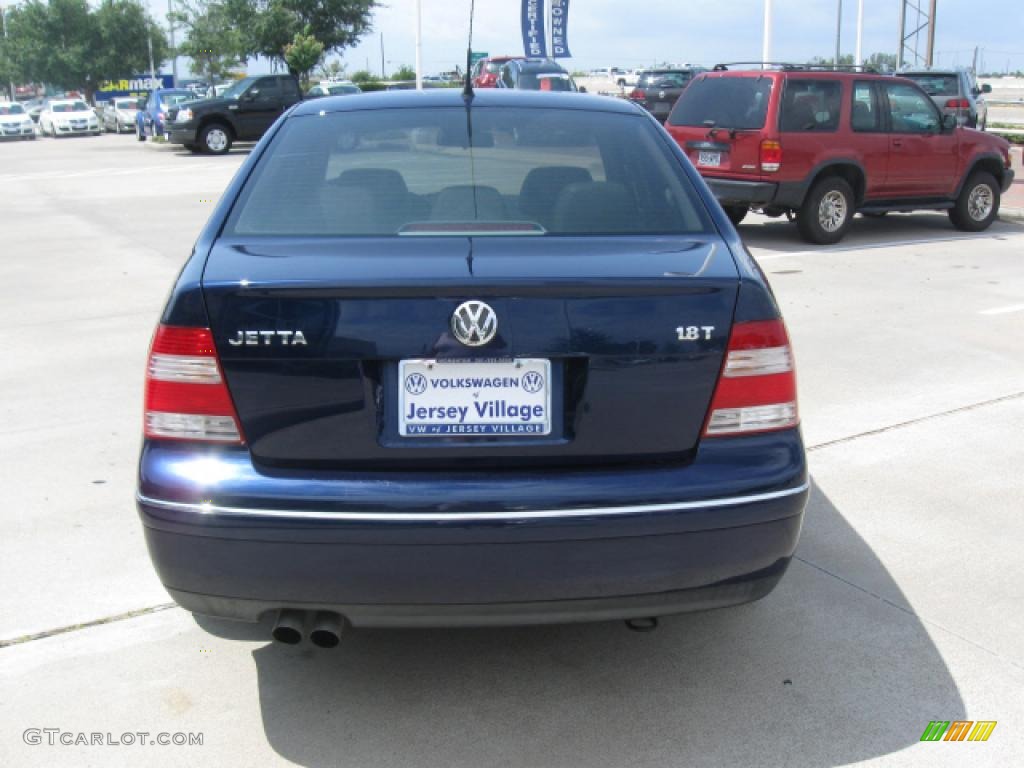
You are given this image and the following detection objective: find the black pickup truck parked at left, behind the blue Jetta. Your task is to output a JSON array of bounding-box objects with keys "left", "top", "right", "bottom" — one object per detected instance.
[{"left": 169, "top": 75, "right": 302, "bottom": 155}]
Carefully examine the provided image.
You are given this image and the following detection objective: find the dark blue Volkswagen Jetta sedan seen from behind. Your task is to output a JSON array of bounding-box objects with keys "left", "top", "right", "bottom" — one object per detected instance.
[{"left": 137, "top": 90, "right": 808, "bottom": 646}]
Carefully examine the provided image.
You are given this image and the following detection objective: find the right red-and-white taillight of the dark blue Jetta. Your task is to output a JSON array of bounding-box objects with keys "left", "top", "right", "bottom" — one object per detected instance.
[{"left": 703, "top": 319, "right": 800, "bottom": 437}]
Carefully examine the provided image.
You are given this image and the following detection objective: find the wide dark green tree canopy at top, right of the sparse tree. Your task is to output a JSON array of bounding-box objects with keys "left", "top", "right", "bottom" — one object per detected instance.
[{"left": 224, "top": 0, "right": 377, "bottom": 61}]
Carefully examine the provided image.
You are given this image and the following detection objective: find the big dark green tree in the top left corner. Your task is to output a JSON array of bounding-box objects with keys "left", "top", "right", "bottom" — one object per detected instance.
[{"left": 5, "top": 0, "right": 168, "bottom": 99}]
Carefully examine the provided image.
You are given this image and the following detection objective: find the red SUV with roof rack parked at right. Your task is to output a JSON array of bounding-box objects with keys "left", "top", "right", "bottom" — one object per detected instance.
[{"left": 666, "top": 65, "right": 1014, "bottom": 243}]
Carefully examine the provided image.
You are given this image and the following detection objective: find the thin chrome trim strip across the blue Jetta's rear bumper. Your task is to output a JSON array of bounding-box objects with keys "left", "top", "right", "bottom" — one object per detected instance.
[{"left": 135, "top": 481, "right": 811, "bottom": 522}]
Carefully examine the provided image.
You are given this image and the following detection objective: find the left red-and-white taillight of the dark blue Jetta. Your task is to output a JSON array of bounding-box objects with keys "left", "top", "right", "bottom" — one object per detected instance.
[{"left": 144, "top": 326, "right": 243, "bottom": 444}]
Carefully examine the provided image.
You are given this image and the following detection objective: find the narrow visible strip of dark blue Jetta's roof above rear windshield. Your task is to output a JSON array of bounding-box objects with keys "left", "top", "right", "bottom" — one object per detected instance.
[{"left": 292, "top": 88, "right": 646, "bottom": 116}]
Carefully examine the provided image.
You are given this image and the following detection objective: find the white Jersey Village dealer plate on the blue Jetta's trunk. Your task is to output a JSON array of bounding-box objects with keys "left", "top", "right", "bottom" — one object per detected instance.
[{"left": 397, "top": 359, "right": 551, "bottom": 437}]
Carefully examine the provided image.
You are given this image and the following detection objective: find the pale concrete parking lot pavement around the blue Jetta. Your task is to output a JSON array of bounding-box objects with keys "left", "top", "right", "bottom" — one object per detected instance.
[{"left": 0, "top": 136, "right": 1024, "bottom": 768}]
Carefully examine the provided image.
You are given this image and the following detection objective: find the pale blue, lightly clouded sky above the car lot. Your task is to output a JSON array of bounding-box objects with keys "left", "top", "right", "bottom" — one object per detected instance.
[{"left": 148, "top": 0, "right": 1024, "bottom": 77}]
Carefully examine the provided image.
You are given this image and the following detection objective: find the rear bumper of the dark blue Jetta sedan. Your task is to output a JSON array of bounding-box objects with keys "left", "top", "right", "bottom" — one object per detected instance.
[{"left": 138, "top": 431, "right": 808, "bottom": 627}]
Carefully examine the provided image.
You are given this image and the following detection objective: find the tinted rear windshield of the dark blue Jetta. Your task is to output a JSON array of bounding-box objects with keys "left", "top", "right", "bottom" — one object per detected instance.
[{"left": 225, "top": 108, "right": 710, "bottom": 237}]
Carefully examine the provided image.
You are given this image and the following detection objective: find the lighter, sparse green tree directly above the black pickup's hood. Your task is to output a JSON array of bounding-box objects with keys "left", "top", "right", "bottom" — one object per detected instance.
[{"left": 168, "top": 0, "right": 246, "bottom": 85}]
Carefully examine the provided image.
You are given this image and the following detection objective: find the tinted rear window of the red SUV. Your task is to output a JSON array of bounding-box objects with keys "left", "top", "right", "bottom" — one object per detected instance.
[{"left": 669, "top": 76, "right": 772, "bottom": 130}]
